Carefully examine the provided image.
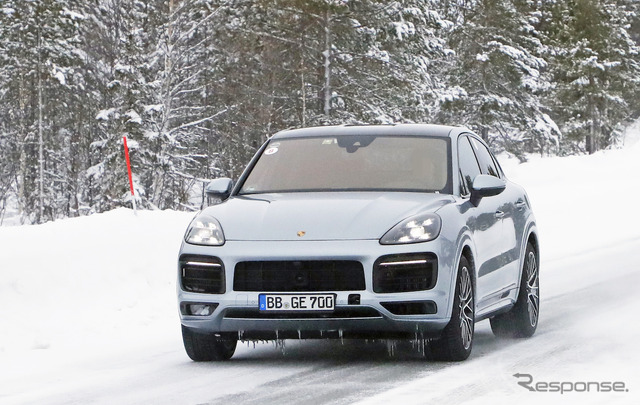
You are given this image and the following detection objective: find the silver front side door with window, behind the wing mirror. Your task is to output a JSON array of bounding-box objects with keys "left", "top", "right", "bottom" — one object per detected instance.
[{"left": 458, "top": 136, "right": 504, "bottom": 308}]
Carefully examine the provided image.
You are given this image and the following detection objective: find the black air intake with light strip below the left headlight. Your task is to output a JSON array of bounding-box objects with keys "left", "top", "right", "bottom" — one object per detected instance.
[{"left": 179, "top": 255, "right": 226, "bottom": 294}]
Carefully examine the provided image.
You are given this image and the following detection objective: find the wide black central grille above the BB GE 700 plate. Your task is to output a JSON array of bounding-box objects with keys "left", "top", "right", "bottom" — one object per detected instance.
[{"left": 233, "top": 260, "right": 365, "bottom": 292}]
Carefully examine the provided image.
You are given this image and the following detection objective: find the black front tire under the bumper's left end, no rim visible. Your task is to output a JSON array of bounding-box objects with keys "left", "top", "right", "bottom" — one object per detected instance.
[{"left": 182, "top": 325, "right": 238, "bottom": 361}]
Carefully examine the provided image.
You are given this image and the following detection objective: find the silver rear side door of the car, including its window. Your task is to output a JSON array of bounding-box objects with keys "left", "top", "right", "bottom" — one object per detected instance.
[{"left": 469, "top": 137, "right": 520, "bottom": 308}]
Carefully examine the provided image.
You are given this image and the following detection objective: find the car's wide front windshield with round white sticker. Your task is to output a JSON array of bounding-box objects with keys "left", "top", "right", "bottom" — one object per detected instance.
[{"left": 240, "top": 135, "right": 452, "bottom": 194}]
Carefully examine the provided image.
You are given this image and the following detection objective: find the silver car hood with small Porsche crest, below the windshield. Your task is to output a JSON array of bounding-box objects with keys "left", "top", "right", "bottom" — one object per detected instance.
[{"left": 203, "top": 192, "right": 453, "bottom": 241}]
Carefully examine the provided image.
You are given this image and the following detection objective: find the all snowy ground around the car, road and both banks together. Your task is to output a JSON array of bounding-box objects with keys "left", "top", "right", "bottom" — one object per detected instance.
[{"left": 0, "top": 136, "right": 640, "bottom": 404}]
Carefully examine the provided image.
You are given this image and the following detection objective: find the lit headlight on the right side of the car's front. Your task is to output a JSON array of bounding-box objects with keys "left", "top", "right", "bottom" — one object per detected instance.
[{"left": 380, "top": 214, "right": 442, "bottom": 245}]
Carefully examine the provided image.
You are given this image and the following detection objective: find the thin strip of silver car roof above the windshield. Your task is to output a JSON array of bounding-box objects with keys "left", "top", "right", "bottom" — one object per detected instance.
[{"left": 271, "top": 124, "right": 471, "bottom": 139}]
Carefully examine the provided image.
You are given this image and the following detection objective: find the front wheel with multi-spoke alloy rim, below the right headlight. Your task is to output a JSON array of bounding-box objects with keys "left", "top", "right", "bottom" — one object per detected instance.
[{"left": 425, "top": 256, "right": 475, "bottom": 361}]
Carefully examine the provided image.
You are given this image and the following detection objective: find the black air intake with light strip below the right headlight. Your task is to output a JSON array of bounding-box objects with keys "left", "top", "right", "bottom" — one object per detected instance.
[{"left": 373, "top": 253, "right": 438, "bottom": 293}]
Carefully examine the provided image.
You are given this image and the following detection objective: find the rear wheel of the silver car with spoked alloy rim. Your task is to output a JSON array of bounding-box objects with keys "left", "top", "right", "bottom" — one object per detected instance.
[{"left": 491, "top": 243, "right": 540, "bottom": 338}]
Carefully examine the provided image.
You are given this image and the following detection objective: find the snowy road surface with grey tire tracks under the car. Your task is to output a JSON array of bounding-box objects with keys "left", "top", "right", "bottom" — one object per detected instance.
[{"left": 0, "top": 235, "right": 640, "bottom": 404}]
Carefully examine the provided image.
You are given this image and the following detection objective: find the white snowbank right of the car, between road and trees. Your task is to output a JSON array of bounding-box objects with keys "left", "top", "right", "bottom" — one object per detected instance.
[{"left": 501, "top": 143, "right": 640, "bottom": 259}]
